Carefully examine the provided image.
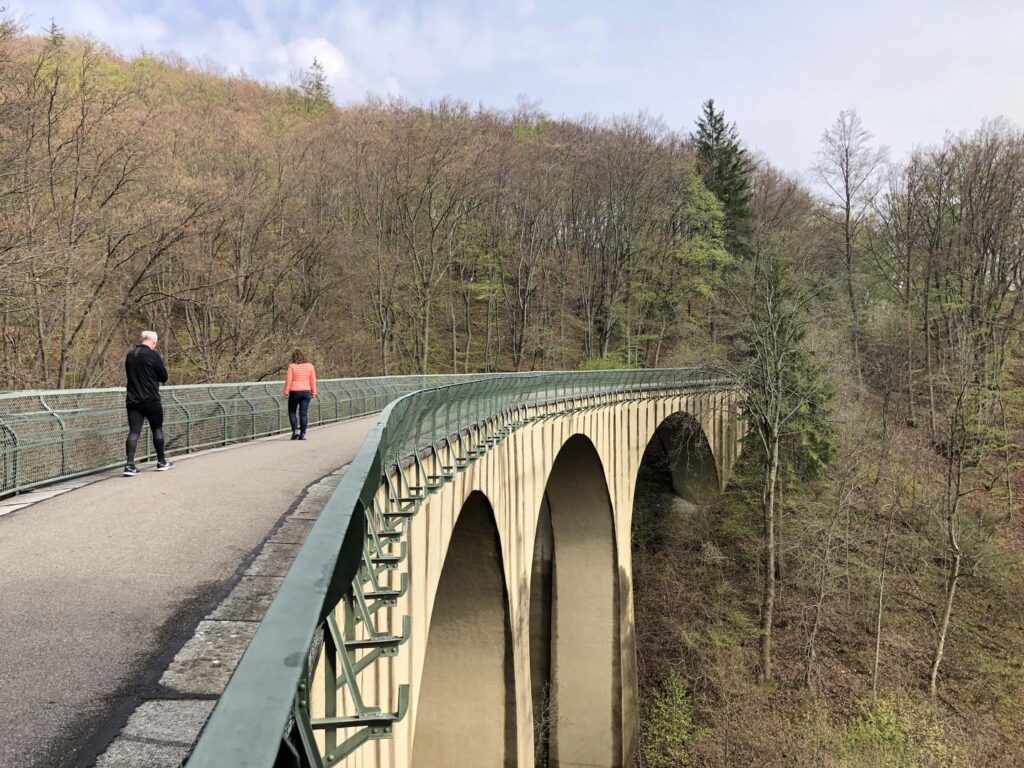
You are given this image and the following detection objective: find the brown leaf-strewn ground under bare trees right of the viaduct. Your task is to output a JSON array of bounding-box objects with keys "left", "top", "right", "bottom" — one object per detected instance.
[{"left": 634, "top": 391, "right": 1024, "bottom": 768}]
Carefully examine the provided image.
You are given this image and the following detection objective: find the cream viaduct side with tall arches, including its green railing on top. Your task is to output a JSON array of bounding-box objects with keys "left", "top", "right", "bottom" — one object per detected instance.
[{"left": 187, "top": 371, "right": 742, "bottom": 768}]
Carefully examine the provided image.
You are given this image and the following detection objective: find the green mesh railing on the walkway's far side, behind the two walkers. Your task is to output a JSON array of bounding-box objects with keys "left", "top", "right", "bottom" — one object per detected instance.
[{"left": 0, "top": 375, "right": 491, "bottom": 497}]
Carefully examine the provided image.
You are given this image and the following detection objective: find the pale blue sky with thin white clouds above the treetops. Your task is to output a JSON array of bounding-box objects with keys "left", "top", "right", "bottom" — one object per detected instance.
[{"left": 8, "top": 0, "right": 1024, "bottom": 174}]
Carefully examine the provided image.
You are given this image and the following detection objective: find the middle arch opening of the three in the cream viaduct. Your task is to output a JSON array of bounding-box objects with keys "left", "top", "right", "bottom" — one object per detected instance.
[{"left": 530, "top": 434, "right": 623, "bottom": 768}]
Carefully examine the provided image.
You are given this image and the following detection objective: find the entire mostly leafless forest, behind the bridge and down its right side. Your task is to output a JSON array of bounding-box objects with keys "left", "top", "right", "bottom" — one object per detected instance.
[{"left": 6, "top": 16, "right": 1024, "bottom": 768}]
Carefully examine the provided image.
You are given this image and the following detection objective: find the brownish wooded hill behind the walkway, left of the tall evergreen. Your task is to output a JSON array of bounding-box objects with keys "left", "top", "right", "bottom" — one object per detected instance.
[{"left": 0, "top": 25, "right": 731, "bottom": 388}]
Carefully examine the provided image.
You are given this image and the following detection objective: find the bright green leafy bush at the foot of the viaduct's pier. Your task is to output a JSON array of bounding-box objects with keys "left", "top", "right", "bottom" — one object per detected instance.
[{"left": 640, "top": 669, "right": 707, "bottom": 768}]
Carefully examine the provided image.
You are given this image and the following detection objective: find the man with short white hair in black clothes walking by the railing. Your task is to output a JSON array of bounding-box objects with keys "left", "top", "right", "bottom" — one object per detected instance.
[{"left": 124, "top": 331, "right": 174, "bottom": 477}]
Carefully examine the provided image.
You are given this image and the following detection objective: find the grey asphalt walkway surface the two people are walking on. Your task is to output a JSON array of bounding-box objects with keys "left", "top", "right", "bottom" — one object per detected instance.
[{"left": 0, "top": 417, "right": 376, "bottom": 768}]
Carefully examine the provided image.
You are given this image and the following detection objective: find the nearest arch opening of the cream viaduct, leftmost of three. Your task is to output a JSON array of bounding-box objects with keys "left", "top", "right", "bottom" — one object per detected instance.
[{"left": 413, "top": 492, "right": 516, "bottom": 768}]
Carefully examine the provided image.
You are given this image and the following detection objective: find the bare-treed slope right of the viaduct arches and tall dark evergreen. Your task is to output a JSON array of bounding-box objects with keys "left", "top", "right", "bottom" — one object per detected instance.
[{"left": 634, "top": 112, "right": 1024, "bottom": 768}]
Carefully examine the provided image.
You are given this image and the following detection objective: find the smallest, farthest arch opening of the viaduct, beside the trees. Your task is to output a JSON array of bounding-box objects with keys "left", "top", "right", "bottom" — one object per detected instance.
[{"left": 642, "top": 413, "right": 721, "bottom": 503}]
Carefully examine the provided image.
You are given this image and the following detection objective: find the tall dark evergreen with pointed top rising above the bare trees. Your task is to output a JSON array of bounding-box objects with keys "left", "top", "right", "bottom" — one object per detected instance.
[{"left": 694, "top": 98, "right": 754, "bottom": 255}]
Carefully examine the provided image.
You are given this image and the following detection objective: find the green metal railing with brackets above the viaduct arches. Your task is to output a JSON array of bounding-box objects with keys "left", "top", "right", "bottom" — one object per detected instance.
[{"left": 187, "top": 370, "right": 732, "bottom": 768}]
